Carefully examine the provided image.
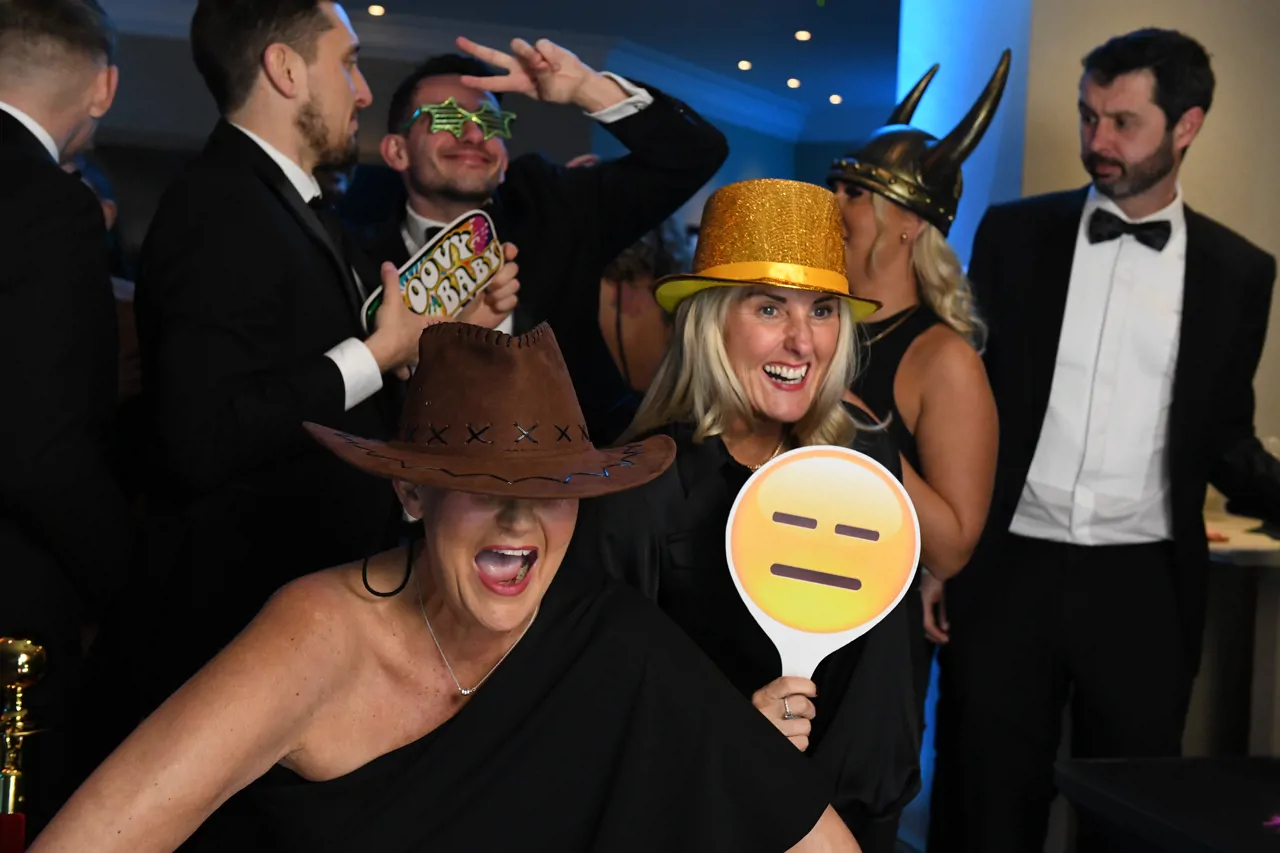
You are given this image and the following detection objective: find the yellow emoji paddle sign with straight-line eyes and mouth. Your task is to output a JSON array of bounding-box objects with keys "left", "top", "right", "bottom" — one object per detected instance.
[{"left": 724, "top": 446, "right": 920, "bottom": 678}]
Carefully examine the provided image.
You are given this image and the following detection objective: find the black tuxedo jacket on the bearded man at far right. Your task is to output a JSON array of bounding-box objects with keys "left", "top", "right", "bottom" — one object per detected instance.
[{"left": 948, "top": 188, "right": 1280, "bottom": 671}]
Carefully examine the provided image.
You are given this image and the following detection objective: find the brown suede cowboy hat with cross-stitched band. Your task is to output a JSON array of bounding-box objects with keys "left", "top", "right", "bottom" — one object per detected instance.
[{"left": 303, "top": 323, "right": 676, "bottom": 498}]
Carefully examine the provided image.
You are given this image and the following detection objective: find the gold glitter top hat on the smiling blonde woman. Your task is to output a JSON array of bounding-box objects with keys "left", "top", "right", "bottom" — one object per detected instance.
[{"left": 654, "top": 178, "right": 879, "bottom": 320}]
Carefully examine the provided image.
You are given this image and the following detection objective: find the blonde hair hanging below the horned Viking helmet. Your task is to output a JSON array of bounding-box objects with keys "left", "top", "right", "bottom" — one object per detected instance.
[{"left": 867, "top": 192, "right": 987, "bottom": 351}]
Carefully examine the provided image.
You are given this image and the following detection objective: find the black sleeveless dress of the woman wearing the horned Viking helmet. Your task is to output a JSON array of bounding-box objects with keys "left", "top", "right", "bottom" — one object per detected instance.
[{"left": 851, "top": 302, "right": 942, "bottom": 733}]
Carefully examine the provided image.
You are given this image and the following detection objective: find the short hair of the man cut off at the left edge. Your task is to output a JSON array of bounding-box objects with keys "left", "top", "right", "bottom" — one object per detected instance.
[{"left": 0, "top": 0, "right": 115, "bottom": 68}]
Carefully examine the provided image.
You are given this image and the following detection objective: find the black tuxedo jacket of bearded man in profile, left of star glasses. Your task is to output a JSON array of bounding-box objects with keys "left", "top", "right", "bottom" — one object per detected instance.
[{"left": 136, "top": 122, "right": 401, "bottom": 691}]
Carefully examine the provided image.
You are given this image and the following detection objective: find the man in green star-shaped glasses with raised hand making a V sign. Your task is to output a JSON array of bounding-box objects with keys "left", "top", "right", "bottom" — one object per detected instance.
[{"left": 365, "top": 44, "right": 728, "bottom": 443}]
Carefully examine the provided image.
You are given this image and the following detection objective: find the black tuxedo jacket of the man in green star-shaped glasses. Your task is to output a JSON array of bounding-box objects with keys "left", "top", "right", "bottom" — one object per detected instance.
[{"left": 362, "top": 83, "right": 728, "bottom": 443}]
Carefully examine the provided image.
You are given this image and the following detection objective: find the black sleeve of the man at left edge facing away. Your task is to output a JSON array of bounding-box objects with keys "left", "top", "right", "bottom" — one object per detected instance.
[{"left": 0, "top": 170, "right": 134, "bottom": 606}]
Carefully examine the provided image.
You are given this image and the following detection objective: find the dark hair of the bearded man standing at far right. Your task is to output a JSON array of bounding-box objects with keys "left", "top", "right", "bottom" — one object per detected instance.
[{"left": 1084, "top": 28, "right": 1213, "bottom": 131}]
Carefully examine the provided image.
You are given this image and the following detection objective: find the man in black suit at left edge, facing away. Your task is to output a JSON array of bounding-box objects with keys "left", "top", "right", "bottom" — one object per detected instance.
[{"left": 0, "top": 0, "right": 134, "bottom": 833}]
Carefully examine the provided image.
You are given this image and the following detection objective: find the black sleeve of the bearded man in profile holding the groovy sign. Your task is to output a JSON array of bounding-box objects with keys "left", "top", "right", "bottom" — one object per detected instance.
[{"left": 137, "top": 185, "right": 346, "bottom": 491}]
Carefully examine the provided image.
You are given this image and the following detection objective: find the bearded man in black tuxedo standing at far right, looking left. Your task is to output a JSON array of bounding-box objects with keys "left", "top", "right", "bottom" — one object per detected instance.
[{"left": 929, "top": 29, "right": 1280, "bottom": 853}]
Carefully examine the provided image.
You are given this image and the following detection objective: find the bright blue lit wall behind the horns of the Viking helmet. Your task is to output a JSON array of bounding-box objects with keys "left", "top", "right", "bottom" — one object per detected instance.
[{"left": 897, "top": 0, "right": 1032, "bottom": 264}]
